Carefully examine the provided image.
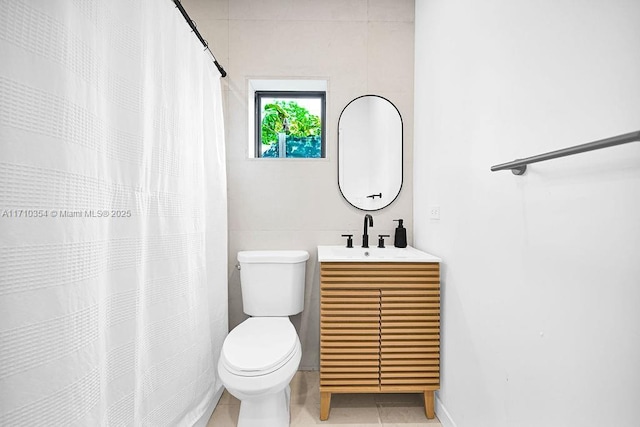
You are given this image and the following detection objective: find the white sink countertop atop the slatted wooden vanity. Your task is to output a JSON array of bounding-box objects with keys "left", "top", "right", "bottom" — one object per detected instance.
[{"left": 318, "top": 246, "right": 440, "bottom": 262}]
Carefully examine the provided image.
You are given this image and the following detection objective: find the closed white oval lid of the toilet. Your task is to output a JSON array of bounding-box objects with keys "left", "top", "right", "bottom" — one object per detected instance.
[{"left": 222, "top": 317, "right": 298, "bottom": 376}]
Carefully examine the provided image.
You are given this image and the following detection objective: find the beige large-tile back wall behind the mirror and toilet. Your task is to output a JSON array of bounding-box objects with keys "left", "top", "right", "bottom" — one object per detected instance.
[{"left": 183, "top": 0, "right": 414, "bottom": 369}]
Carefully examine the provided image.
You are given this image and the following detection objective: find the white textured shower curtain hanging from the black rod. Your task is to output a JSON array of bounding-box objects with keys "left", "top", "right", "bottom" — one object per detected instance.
[{"left": 0, "top": 0, "right": 227, "bottom": 426}]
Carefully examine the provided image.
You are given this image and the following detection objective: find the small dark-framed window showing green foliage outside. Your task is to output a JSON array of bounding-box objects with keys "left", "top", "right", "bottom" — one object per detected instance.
[{"left": 253, "top": 90, "right": 326, "bottom": 158}]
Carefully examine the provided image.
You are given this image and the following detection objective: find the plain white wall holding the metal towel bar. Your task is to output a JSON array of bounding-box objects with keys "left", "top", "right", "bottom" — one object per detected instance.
[{"left": 414, "top": 0, "right": 640, "bottom": 427}]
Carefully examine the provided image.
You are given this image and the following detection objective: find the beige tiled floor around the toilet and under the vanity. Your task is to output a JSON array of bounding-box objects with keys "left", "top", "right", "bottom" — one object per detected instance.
[{"left": 207, "top": 371, "right": 442, "bottom": 427}]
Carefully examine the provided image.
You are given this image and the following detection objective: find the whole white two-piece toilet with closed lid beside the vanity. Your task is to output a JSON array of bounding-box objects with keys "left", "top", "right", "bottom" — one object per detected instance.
[{"left": 218, "top": 251, "right": 309, "bottom": 427}]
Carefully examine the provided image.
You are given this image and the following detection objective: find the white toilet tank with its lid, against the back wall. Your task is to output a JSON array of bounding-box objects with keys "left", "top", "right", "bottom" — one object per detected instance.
[{"left": 238, "top": 251, "right": 309, "bottom": 316}]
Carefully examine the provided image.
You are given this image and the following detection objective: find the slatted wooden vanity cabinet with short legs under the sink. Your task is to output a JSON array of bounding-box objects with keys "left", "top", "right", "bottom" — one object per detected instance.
[{"left": 320, "top": 262, "right": 440, "bottom": 420}]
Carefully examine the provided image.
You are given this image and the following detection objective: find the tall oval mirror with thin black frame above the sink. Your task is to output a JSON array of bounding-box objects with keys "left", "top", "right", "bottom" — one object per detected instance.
[{"left": 338, "top": 95, "right": 402, "bottom": 211}]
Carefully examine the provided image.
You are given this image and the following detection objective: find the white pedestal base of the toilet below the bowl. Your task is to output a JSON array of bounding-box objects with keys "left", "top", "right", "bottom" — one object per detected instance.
[{"left": 238, "top": 385, "right": 291, "bottom": 427}]
